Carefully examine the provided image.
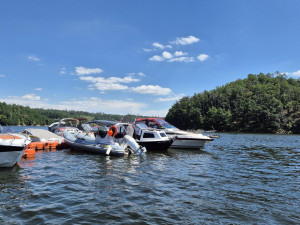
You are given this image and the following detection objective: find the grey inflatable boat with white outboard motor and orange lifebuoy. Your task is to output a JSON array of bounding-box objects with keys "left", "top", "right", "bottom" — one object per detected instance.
[{"left": 63, "top": 120, "right": 146, "bottom": 156}]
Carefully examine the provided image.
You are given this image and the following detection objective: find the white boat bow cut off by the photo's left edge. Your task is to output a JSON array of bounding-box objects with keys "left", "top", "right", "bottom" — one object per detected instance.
[{"left": 0, "top": 133, "right": 31, "bottom": 167}]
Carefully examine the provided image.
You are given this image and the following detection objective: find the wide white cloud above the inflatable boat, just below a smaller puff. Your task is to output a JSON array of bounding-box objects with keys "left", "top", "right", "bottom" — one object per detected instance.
[{"left": 79, "top": 76, "right": 140, "bottom": 92}]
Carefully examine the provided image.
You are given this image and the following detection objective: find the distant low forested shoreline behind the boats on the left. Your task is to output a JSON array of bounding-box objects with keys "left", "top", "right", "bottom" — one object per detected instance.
[{"left": 0, "top": 102, "right": 142, "bottom": 126}]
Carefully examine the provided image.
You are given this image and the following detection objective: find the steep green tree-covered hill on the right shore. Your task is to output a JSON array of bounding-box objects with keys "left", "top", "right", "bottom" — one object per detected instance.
[{"left": 166, "top": 73, "right": 300, "bottom": 133}]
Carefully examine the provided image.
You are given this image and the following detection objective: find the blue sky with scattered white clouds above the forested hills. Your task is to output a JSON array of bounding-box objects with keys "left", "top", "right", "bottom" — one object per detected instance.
[{"left": 0, "top": 0, "right": 300, "bottom": 116}]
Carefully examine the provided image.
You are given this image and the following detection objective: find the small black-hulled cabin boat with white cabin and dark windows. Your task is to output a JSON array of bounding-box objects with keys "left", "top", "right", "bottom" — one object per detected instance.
[{"left": 133, "top": 124, "right": 174, "bottom": 151}]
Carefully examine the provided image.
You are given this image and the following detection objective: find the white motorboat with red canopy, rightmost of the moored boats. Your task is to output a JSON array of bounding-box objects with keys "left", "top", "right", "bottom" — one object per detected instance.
[{"left": 135, "top": 118, "right": 213, "bottom": 149}]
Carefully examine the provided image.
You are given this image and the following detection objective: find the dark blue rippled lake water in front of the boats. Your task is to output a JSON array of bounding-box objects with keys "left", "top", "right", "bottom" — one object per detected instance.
[{"left": 0, "top": 128, "right": 300, "bottom": 224}]
